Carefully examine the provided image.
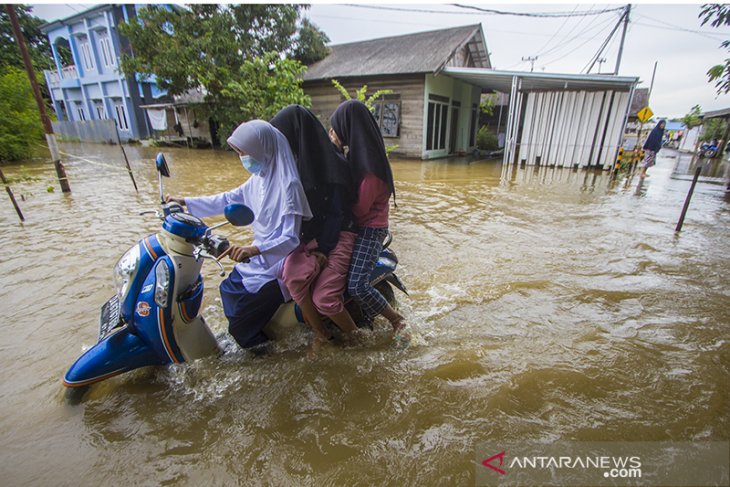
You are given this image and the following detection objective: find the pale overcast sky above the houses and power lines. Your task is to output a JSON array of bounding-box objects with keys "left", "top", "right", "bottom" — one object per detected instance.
[{"left": 34, "top": 2, "right": 730, "bottom": 117}]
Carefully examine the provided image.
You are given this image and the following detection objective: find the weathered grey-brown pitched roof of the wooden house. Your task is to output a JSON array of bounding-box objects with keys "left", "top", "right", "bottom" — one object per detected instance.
[{"left": 304, "top": 24, "right": 491, "bottom": 81}]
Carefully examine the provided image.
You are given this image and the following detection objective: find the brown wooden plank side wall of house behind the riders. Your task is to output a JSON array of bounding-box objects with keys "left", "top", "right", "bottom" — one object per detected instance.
[{"left": 304, "top": 75, "right": 424, "bottom": 158}]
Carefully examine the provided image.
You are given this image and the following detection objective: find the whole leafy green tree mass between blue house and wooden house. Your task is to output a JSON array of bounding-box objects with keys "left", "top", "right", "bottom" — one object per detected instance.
[{"left": 119, "top": 4, "right": 327, "bottom": 145}]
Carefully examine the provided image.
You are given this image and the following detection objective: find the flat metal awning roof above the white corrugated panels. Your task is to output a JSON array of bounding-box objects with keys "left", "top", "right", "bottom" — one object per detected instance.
[{"left": 441, "top": 67, "right": 639, "bottom": 93}]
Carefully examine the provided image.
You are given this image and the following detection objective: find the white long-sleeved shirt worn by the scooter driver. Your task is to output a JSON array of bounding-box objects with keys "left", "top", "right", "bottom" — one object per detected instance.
[{"left": 185, "top": 183, "right": 302, "bottom": 301}]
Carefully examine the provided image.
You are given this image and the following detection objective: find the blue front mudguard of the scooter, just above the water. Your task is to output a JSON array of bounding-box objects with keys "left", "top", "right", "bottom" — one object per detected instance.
[{"left": 63, "top": 326, "right": 168, "bottom": 387}]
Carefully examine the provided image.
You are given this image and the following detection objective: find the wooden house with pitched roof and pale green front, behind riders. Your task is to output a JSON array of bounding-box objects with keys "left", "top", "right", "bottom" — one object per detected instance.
[{"left": 303, "top": 24, "right": 491, "bottom": 159}]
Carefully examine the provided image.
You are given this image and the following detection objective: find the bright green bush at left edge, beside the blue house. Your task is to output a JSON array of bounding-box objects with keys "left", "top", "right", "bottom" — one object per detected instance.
[{"left": 0, "top": 67, "right": 43, "bottom": 161}]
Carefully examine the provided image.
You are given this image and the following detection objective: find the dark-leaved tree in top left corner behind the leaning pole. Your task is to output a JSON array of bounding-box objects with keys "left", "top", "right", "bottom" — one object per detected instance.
[{"left": 0, "top": 5, "right": 53, "bottom": 72}]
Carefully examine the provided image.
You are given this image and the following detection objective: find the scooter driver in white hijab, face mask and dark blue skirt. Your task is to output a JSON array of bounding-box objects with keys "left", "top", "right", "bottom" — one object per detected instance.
[{"left": 168, "top": 120, "right": 312, "bottom": 348}]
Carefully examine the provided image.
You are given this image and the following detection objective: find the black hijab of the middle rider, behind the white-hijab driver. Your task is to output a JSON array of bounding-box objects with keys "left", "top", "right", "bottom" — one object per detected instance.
[{"left": 271, "top": 105, "right": 350, "bottom": 191}]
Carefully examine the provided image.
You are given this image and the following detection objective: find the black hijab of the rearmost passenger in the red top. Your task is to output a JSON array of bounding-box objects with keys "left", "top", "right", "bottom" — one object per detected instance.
[{"left": 330, "top": 100, "right": 395, "bottom": 198}]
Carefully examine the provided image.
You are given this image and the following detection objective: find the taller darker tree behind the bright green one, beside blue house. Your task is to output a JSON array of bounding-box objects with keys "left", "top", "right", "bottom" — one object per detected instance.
[{"left": 119, "top": 4, "right": 328, "bottom": 95}]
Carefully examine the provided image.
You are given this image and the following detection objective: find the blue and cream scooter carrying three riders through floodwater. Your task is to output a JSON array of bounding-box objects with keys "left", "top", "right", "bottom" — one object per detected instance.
[{"left": 63, "top": 153, "right": 407, "bottom": 395}]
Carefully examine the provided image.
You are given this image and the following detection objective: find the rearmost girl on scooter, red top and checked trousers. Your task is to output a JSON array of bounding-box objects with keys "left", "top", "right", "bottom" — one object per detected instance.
[{"left": 330, "top": 100, "right": 408, "bottom": 340}]
